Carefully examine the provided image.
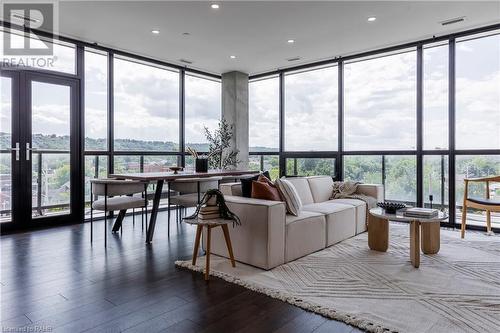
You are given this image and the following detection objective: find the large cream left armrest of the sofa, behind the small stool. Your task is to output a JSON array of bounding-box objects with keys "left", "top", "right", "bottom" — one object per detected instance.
[{"left": 203, "top": 196, "right": 286, "bottom": 269}]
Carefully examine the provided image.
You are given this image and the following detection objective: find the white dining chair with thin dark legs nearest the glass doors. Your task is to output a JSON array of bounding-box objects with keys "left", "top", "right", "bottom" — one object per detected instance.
[{"left": 90, "top": 179, "right": 148, "bottom": 247}]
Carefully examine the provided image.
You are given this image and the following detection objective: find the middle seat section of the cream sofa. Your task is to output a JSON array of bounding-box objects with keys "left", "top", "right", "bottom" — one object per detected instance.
[{"left": 303, "top": 201, "right": 356, "bottom": 246}]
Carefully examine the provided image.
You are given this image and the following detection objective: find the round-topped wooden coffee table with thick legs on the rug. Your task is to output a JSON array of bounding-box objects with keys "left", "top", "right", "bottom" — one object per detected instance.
[{"left": 368, "top": 208, "right": 448, "bottom": 268}]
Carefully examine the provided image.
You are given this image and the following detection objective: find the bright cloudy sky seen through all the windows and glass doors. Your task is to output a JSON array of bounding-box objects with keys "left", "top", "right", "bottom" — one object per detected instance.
[{"left": 1, "top": 30, "right": 500, "bottom": 151}]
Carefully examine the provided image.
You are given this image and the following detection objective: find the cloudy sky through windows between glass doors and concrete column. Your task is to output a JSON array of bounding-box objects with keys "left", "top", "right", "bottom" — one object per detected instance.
[{"left": 85, "top": 52, "right": 221, "bottom": 148}]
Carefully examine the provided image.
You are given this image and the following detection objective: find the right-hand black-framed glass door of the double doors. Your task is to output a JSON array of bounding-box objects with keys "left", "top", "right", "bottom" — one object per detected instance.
[{"left": 23, "top": 74, "right": 81, "bottom": 224}]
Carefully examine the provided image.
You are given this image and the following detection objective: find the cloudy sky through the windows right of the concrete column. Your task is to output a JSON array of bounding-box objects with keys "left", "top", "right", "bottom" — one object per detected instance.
[{"left": 249, "top": 35, "right": 500, "bottom": 151}]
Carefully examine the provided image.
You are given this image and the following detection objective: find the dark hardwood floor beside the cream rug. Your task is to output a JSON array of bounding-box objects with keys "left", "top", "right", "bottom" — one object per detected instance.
[{"left": 0, "top": 213, "right": 361, "bottom": 333}]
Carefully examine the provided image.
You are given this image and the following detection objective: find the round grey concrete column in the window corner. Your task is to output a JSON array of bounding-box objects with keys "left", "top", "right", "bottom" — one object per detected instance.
[{"left": 222, "top": 72, "right": 248, "bottom": 170}]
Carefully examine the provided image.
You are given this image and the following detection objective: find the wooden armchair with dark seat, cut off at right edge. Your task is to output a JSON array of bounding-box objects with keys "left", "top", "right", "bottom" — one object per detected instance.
[{"left": 461, "top": 176, "right": 500, "bottom": 238}]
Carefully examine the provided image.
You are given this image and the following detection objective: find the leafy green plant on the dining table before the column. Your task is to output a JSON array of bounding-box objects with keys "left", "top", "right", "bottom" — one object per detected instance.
[{"left": 205, "top": 119, "right": 240, "bottom": 169}]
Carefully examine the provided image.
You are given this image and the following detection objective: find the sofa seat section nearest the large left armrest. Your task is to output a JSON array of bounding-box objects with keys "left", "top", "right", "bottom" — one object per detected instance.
[{"left": 285, "top": 211, "right": 326, "bottom": 262}]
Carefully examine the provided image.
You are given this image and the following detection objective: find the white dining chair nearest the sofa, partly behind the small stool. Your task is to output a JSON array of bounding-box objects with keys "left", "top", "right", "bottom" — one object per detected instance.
[{"left": 168, "top": 177, "right": 222, "bottom": 235}]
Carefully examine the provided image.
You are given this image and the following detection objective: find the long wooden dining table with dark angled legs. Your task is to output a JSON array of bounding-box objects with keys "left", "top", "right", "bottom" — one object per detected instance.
[{"left": 109, "top": 170, "right": 259, "bottom": 244}]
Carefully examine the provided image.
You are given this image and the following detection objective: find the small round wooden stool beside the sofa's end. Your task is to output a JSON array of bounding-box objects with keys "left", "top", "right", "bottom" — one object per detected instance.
[{"left": 183, "top": 218, "right": 236, "bottom": 281}]
